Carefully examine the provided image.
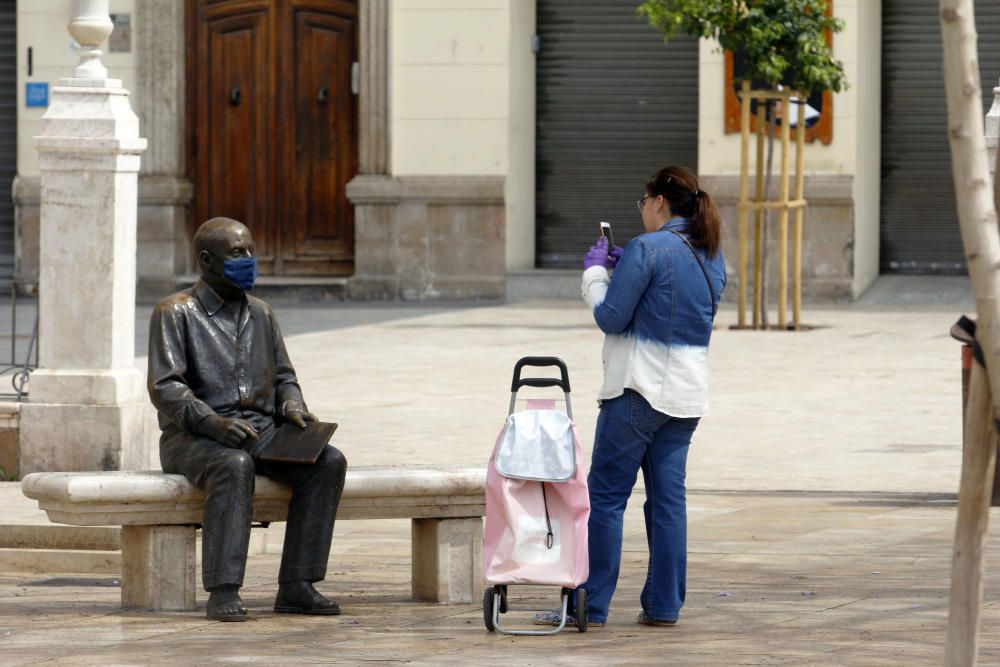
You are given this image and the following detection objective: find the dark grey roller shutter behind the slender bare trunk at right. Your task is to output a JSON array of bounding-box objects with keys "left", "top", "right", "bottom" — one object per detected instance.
[{"left": 881, "top": 0, "right": 1000, "bottom": 273}]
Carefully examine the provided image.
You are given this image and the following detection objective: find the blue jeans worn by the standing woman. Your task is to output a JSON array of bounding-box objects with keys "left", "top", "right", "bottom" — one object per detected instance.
[{"left": 584, "top": 389, "right": 699, "bottom": 622}]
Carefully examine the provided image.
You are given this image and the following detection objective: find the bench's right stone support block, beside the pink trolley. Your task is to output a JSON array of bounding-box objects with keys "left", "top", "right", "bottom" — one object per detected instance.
[{"left": 411, "top": 517, "right": 483, "bottom": 602}]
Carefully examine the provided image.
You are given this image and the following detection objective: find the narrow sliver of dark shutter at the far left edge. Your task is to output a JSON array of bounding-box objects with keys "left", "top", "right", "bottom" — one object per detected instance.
[{"left": 0, "top": 0, "right": 17, "bottom": 289}]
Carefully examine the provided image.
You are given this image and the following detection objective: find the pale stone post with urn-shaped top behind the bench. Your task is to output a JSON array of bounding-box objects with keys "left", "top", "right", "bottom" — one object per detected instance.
[{"left": 20, "top": 0, "right": 153, "bottom": 475}]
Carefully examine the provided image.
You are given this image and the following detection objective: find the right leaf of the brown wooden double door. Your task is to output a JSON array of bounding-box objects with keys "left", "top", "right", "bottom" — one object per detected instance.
[{"left": 283, "top": 3, "right": 358, "bottom": 272}]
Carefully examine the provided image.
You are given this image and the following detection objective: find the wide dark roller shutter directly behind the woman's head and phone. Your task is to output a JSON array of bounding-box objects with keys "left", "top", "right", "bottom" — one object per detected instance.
[{"left": 535, "top": 0, "right": 700, "bottom": 267}]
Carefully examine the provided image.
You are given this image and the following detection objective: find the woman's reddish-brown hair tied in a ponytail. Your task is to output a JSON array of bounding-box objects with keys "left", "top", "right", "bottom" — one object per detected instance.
[{"left": 646, "top": 165, "right": 722, "bottom": 257}]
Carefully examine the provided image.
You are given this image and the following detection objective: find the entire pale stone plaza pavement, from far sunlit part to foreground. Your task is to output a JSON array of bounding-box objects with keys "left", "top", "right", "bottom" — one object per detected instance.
[{"left": 0, "top": 294, "right": 1000, "bottom": 665}]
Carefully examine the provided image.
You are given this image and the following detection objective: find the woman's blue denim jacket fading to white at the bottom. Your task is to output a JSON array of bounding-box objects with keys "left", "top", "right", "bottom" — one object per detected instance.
[{"left": 582, "top": 218, "right": 726, "bottom": 417}]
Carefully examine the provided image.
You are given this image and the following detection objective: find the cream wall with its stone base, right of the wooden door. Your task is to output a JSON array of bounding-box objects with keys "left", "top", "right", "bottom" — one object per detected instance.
[{"left": 360, "top": 0, "right": 508, "bottom": 300}]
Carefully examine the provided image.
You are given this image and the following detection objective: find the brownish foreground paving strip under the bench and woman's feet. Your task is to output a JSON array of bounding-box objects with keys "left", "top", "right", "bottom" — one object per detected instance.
[{"left": 0, "top": 492, "right": 1000, "bottom": 665}]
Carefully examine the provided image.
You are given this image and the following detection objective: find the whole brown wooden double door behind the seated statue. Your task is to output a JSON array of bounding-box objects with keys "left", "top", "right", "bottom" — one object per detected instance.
[{"left": 187, "top": 0, "right": 358, "bottom": 276}]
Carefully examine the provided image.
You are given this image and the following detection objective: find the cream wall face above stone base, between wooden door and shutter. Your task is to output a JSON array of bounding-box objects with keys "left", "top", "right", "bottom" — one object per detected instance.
[{"left": 391, "top": 0, "right": 511, "bottom": 176}]
